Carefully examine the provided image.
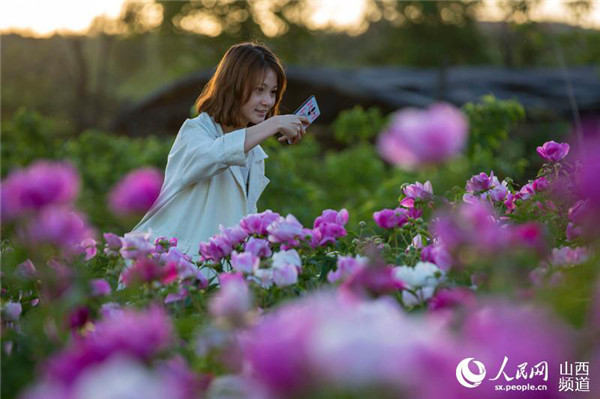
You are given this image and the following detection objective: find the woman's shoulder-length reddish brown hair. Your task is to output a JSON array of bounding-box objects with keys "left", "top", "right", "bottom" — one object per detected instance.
[{"left": 196, "top": 43, "right": 287, "bottom": 127}]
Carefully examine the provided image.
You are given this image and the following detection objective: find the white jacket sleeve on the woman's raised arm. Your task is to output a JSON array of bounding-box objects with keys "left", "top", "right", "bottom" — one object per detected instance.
[{"left": 173, "top": 125, "right": 246, "bottom": 186}]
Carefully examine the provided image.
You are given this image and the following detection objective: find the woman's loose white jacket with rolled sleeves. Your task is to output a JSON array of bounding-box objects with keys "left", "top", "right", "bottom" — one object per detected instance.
[{"left": 133, "top": 113, "right": 269, "bottom": 261}]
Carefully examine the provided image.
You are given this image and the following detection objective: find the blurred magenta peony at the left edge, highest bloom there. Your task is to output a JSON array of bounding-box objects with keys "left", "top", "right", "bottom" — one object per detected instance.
[{"left": 0, "top": 161, "right": 79, "bottom": 221}]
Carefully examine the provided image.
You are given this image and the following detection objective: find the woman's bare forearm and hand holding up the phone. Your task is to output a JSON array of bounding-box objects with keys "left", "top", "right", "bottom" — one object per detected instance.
[{"left": 244, "top": 115, "right": 308, "bottom": 153}]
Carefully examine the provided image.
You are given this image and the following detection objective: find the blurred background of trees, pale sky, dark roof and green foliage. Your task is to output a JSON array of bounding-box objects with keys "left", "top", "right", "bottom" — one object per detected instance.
[{"left": 0, "top": 0, "right": 600, "bottom": 234}]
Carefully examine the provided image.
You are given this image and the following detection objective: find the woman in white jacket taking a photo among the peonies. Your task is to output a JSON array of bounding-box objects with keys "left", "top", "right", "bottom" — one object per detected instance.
[{"left": 133, "top": 43, "right": 308, "bottom": 260}]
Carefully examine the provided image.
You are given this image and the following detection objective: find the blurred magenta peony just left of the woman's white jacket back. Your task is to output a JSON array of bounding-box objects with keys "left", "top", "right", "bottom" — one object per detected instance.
[{"left": 108, "top": 168, "right": 163, "bottom": 216}]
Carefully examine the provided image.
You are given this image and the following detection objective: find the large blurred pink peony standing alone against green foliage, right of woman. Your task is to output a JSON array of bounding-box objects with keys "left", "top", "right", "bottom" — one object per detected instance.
[{"left": 377, "top": 103, "right": 468, "bottom": 170}]
